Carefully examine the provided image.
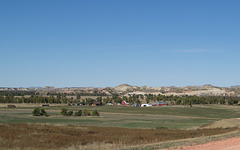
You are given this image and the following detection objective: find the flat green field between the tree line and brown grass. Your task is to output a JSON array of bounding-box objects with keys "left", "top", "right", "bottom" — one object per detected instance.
[{"left": 0, "top": 105, "right": 240, "bottom": 129}]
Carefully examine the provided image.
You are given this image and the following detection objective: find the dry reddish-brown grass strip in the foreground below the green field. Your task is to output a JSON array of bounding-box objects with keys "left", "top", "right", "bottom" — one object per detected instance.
[{"left": 0, "top": 124, "right": 237, "bottom": 149}]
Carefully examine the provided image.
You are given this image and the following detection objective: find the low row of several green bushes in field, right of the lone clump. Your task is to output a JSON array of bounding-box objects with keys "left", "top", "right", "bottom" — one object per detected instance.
[{"left": 61, "top": 108, "right": 100, "bottom": 116}]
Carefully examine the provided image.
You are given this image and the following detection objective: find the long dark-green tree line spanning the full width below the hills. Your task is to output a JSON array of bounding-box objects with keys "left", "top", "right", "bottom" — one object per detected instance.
[{"left": 0, "top": 94, "right": 240, "bottom": 105}]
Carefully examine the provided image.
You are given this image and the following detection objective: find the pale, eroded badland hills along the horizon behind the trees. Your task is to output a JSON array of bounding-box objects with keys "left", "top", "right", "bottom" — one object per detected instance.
[{"left": 0, "top": 84, "right": 240, "bottom": 96}]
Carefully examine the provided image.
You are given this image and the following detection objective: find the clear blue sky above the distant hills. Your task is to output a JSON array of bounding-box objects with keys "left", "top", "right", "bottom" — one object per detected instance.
[{"left": 0, "top": 0, "right": 240, "bottom": 87}]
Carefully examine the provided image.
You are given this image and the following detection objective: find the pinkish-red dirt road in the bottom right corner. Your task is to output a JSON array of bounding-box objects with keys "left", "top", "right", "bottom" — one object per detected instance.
[{"left": 170, "top": 137, "right": 240, "bottom": 150}]
